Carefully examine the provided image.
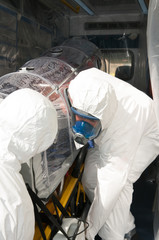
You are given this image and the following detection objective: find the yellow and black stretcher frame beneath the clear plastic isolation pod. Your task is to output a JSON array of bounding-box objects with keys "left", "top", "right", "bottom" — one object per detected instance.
[{"left": 27, "top": 146, "right": 89, "bottom": 240}]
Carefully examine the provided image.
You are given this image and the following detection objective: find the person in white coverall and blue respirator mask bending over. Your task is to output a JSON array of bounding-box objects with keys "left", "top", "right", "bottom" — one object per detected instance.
[{"left": 68, "top": 68, "right": 159, "bottom": 240}]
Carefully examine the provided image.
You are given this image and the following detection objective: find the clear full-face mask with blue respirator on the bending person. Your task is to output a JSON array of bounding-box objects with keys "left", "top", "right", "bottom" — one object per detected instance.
[{"left": 65, "top": 90, "right": 102, "bottom": 147}]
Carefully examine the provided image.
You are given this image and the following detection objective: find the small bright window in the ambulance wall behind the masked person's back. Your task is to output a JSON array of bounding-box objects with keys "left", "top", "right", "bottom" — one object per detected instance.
[{"left": 102, "top": 50, "right": 134, "bottom": 81}]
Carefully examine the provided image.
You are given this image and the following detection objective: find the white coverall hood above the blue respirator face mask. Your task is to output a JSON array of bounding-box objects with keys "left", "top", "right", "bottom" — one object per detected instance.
[{"left": 68, "top": 68, "right": 117, "bottom": 129}]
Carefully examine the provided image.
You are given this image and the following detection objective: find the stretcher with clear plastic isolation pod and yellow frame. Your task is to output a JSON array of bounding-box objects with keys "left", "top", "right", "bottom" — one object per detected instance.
[{"left": 0, "top": 38, "right": 101, "bottom": 240}]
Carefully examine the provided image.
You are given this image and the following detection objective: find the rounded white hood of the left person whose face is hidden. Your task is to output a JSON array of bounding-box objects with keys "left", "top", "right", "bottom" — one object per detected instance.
[{"left": 0, "top": 89, "right": 57, "bottom": 171}]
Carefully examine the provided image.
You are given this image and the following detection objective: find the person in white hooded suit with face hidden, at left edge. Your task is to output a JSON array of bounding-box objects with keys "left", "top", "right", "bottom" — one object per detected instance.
[{"left": 0, "top": 88, "right": 57, "bottom": 240}]
